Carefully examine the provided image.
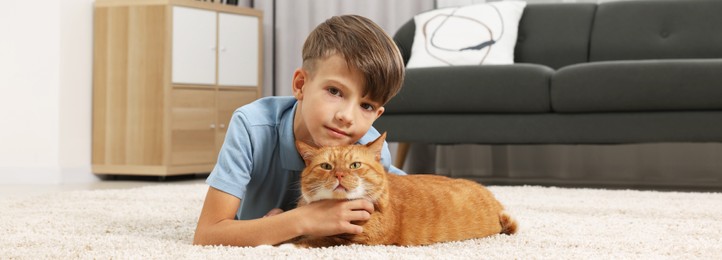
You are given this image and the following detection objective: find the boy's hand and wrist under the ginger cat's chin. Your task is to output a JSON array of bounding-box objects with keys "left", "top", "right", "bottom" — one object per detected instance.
[{"left": 297, "top": 199, "right": 374, "bottom": 237}]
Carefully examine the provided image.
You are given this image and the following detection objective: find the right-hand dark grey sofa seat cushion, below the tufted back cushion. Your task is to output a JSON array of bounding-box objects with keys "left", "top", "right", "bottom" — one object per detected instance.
[{"left": 551, "top": 59, "right": 722, "bottom": 112}]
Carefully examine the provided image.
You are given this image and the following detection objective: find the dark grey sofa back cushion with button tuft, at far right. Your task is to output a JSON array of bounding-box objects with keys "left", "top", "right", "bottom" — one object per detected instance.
[{"left": 589, "top": 0, "right": 722, "bottom": 61}]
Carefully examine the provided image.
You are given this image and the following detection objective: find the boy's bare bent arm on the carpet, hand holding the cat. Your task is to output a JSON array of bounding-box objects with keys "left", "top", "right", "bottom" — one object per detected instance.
[{"left": 193, "top": 187, "right": 373, "bottom": 246}]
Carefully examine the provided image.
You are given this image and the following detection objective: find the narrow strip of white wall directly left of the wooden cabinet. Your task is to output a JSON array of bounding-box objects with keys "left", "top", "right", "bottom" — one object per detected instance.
[{"left": 58, "top": 0, "right": 97, "bottom": 182}]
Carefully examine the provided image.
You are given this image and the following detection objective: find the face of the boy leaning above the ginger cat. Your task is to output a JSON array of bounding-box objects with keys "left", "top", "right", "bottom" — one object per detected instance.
[{"left": 293, "top": 55, "right": 384, "bottom": 146}]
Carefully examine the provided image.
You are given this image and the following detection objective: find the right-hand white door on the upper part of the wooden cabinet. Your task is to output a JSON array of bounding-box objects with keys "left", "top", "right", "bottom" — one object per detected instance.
[{"left": 218, "top": 13, "right": 260, "bottom": 87}]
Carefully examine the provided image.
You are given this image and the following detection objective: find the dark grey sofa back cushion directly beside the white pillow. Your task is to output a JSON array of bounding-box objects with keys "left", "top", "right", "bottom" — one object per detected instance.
[{"left": 514, "top": 3, "right": 597, "bottom": 69}]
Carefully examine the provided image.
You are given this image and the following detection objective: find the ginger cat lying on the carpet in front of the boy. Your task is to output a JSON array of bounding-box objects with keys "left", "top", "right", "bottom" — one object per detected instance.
[{"left": 295, "top": 133, "right": 517, "bottom": 247}]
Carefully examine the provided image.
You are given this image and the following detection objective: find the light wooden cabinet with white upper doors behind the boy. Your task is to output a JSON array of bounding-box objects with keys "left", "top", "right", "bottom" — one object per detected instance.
[{"left": 92, "top": 0, "right": 263, "bottom": 176}]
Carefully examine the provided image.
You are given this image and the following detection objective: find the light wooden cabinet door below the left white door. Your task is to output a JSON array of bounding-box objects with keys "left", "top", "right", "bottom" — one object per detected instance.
[{"left": 170, "top": 89, "right": 218, "bottom": 165}]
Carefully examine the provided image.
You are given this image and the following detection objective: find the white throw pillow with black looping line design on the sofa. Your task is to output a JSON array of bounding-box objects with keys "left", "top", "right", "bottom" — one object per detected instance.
[{"left": 406, "top": 1, "right": 526, "bottom": 68}]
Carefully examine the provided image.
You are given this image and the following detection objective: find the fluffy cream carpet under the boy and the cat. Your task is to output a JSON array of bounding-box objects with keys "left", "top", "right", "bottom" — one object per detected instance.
[{"left": 0, "top": 184, "right": 722, "bottom": 259}]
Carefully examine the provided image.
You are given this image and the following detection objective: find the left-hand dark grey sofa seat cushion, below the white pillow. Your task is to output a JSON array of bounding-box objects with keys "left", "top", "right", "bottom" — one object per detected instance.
[{"left": 385, "top": 64, "right": 554, "bottom": 114}]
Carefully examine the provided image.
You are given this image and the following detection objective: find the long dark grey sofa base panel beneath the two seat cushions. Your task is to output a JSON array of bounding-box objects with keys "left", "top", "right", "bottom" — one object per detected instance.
[{"left": 374, "top": 111, "right": 722, "bottom": 144}]
